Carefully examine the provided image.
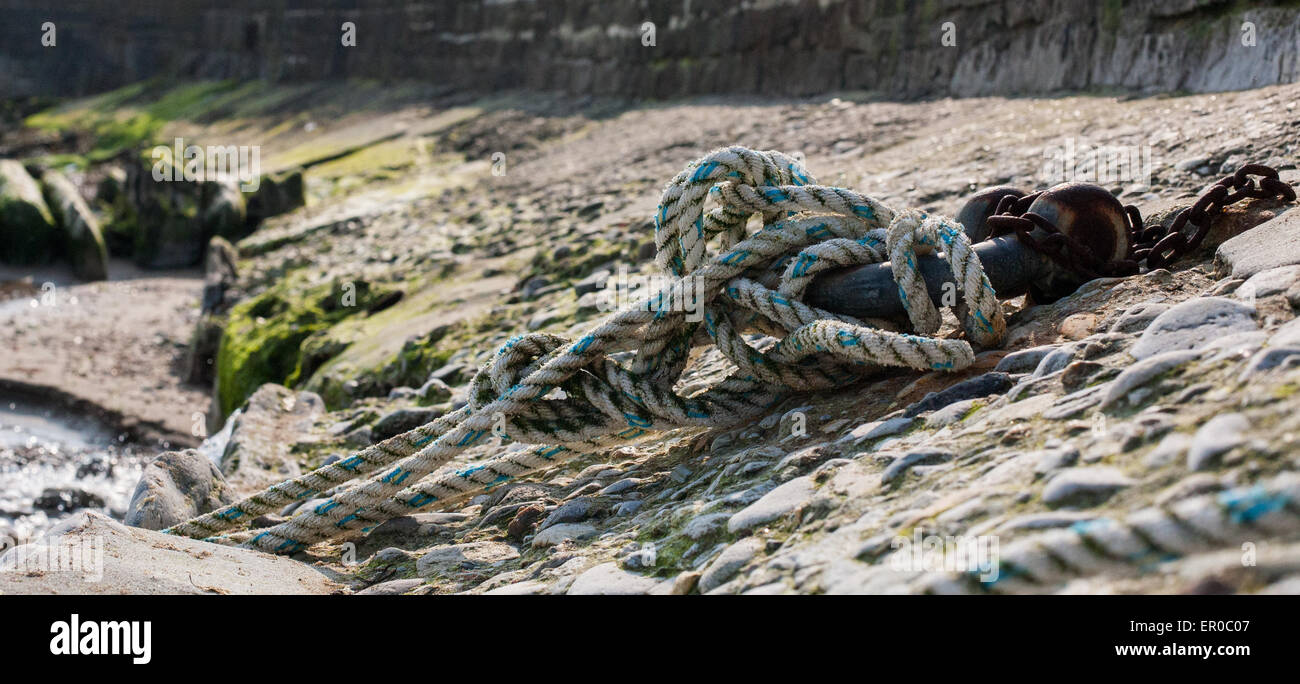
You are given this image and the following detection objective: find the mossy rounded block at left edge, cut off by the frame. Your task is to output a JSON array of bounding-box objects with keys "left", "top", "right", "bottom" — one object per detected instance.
[{"left": 0, "top": 159, "right": 59, "bottom": 265}]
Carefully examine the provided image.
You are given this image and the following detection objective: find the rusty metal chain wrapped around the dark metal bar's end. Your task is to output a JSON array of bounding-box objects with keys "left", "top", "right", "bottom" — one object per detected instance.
[{"left": 988, "top": 164, "right": 1296, "bottom": 280}]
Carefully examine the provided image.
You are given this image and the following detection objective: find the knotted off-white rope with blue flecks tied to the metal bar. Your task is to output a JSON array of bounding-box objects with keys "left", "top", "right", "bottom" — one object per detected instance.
[{"left": 166, "top": 147, "right": 1005, "bottom": 553}]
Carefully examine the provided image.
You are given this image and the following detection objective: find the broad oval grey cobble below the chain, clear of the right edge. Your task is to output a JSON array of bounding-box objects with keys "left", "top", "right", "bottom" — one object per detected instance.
[{"left": 1128, "top": 296, "right": 1258, "bottom": 360}]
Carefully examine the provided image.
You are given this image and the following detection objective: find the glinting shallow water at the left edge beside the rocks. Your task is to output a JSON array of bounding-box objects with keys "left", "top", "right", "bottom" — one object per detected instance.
[{"left": 0, "top": 397, "right": 142, "bottom": 544}]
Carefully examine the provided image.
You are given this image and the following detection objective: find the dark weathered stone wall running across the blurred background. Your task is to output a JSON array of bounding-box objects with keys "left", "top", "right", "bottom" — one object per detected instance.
[{"left": 0, "top": 0, "right": 1300, "bottom": 99}]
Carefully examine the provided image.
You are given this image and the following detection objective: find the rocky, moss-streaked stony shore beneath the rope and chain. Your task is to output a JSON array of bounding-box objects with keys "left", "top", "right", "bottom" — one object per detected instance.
[{"left": 0, "top": 3, "right": 1300, "bottom": 594}]
